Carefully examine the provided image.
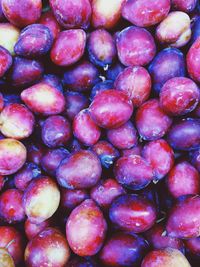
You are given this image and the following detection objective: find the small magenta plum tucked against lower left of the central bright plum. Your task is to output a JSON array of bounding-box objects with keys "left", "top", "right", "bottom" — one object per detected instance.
[{"left": 73, "top": 109, "right": 101, "bottom": 146}]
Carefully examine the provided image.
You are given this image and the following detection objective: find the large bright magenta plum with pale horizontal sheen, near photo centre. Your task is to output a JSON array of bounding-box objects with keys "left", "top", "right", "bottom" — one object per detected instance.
[{"left": 89, "top": 89, "right": 133, "bottom": 129}]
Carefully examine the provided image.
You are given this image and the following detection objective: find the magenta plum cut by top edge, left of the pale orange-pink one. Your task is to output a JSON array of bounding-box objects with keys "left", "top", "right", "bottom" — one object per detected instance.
[{"left": 49, "top": 0, "right": 92, "bottom": 29}]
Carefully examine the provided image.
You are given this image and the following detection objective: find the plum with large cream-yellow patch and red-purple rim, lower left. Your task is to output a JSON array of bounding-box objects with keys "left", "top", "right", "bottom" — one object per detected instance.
[{"left": 23, "top": 176, "right": 60, "bottom": 223}]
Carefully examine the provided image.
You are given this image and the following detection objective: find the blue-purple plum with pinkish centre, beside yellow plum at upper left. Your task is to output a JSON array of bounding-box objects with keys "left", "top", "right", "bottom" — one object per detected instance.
[{"left": 14, "top": 24, "right": 53, "bottom": 58}]
